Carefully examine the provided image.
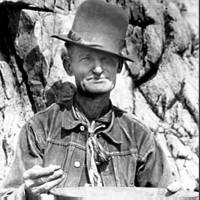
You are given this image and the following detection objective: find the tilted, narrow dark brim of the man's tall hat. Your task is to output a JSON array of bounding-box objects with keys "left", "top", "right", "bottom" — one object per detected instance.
[{"left": 51, "top": 35, "right": 134, "bottom": 62}]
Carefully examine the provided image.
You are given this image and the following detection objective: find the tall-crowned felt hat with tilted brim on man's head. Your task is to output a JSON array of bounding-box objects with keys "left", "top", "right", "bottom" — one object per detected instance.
[{"left": 52, "top": 0, "right": 133, "bottom": 62}]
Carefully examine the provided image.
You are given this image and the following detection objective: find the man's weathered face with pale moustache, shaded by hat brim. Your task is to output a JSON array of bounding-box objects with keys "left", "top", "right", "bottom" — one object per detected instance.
[{"left": 70, "top": 46, "right": 119, "bottom": 94}]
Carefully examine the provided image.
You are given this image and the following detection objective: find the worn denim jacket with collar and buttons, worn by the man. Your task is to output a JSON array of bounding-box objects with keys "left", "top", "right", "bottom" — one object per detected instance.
[{"left": 0, "top": 103, "right": 175, "bottom": 199}]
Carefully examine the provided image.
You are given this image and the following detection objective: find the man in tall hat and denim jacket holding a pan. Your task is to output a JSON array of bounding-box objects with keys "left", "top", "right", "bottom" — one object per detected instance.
[{"left": 1, "top": 0, "right": 177, "bottom": 199}]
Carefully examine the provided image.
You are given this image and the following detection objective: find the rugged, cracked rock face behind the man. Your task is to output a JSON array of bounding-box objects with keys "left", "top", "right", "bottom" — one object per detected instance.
[{"left": 0, "top": 0, "right": 199, "bottom": 190}]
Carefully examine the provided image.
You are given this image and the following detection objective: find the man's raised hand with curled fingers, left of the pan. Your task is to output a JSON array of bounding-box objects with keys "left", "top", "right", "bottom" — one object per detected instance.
[{"left": 23, "top": 165, "right": 64, "bottom": 196}]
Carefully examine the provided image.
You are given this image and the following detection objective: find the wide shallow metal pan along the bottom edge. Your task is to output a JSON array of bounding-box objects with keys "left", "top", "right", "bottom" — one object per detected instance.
[{"left": 50, "top": 187, "right": 199, "bottom": 200}]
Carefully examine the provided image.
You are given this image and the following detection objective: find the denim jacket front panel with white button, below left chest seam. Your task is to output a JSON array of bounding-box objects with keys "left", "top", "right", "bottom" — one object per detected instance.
[{"left": 44, "top": 138, "right": 85, "bottom": 187}]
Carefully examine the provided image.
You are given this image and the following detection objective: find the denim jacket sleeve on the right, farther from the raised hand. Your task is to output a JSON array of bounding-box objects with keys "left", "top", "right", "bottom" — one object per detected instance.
[{"left": 135, "top": 122, "right": 177, "bottom": 188}]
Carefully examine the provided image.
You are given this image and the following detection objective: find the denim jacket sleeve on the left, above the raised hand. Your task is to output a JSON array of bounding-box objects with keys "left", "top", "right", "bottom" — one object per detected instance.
[{"left": 0, "top": 119, "right": 43, "bottom": 200}]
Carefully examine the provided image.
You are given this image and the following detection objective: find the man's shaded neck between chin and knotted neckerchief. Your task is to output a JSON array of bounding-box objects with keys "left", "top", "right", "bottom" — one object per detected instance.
[{"left": 75, "top": 90, "right": 110, "bottom": 121}]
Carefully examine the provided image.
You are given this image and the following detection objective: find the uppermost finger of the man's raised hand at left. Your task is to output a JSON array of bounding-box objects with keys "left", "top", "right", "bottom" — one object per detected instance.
[{"left": 23, "top": 165, "right": 60, "bottom": 179}]
